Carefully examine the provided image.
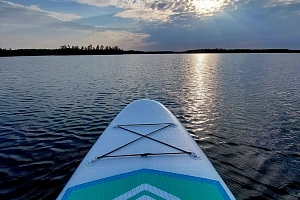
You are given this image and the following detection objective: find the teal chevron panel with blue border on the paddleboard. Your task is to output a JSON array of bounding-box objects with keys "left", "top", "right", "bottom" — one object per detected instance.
[{"left": 63, "top": 169, "right": 230, "bottom": 200}]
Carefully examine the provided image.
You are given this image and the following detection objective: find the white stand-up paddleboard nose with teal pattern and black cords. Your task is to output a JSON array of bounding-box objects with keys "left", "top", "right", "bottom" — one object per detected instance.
[{"left": 58, "top": 100, "right": 235, "bottom": 200}]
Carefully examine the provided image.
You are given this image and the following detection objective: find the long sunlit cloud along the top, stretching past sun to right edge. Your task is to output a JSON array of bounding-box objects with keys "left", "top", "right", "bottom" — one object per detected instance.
[{"left": 73, "top": 0, "right": 300, "bottom": 23}]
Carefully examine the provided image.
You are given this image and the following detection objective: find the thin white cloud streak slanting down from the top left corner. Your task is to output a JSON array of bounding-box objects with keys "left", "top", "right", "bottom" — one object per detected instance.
[{"left": 0, "top": 1, "right": 80, "bottom": 21}]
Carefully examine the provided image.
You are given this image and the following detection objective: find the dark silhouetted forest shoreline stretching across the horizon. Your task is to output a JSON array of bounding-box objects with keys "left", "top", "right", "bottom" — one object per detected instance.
[{"left": 0, "top": 44, "right": 300, "bottom": 57}]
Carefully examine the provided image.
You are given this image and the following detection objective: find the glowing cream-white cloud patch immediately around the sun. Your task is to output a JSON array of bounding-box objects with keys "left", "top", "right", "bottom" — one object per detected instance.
[{"left": 74, "top": 0, "right": 237, "bottom": 22}]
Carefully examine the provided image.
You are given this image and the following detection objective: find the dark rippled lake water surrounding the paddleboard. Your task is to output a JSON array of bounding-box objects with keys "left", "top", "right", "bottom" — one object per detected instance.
[{"left": 0, "top": 54, "right": 300, "bottom": 200}]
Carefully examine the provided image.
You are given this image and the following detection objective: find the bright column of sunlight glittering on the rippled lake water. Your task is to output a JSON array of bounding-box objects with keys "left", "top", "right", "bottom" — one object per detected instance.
[{"left": 180, "top": 54, "right": 219, "bottom": 141}]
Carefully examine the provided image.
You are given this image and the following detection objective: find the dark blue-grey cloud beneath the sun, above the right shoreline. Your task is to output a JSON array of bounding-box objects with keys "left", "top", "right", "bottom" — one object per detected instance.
[{"left": 138, "top": 1, "right": 300, "bottom": 50}]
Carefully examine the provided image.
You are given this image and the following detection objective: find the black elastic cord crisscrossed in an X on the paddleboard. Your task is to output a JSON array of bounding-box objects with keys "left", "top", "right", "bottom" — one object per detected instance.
[{"left": 96, "top": 123, "right": 191, "bottom": 159}]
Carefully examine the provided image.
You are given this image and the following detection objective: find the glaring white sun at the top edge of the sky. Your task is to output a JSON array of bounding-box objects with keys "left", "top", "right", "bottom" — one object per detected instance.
[{"left": 193, "top": 0, "right": 222, "bottom": 15}]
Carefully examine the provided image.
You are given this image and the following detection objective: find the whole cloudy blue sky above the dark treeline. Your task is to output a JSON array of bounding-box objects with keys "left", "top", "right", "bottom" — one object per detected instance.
[{"left": 0, "top": 0, "right": 300, "bottom": 51}]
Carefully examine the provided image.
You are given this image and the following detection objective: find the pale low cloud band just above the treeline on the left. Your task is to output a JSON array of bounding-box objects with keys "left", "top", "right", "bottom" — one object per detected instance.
[{"left": 0, "top": 26, "right": 150, "bottom": 49}]
